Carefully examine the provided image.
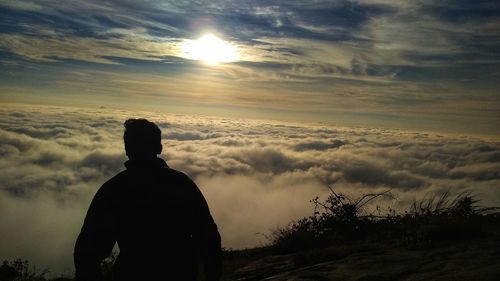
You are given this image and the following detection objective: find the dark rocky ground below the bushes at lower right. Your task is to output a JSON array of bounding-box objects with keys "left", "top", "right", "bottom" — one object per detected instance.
[{"left": 225, "top": 237, "right": 500, "bottom": 281}]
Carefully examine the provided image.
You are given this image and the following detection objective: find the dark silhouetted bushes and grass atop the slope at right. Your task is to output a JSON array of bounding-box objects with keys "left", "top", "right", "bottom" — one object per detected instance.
[{"left": 269, "top": 188, "right": 500, "bottom": 253}]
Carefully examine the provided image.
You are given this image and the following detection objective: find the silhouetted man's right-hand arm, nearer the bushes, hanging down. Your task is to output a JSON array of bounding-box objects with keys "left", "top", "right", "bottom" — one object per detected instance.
[{"left": 188, "top": 175, "right": 222, "bottom": 281}]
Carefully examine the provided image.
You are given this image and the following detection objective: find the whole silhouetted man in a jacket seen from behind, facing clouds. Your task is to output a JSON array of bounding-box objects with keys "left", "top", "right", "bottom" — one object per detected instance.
[{"left": 74, "top": 119, "right": 221, "bottom": 281}]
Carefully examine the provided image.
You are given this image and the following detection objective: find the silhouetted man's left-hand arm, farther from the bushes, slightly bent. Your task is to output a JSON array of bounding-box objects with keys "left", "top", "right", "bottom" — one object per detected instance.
[{"left": 73, "top": 185, "right": 116, "bottom": 281}]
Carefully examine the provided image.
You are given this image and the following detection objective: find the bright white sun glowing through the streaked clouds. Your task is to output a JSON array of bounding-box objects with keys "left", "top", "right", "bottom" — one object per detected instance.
[{"left": 182, "top": 34, "right": 238, "bottom": 65}]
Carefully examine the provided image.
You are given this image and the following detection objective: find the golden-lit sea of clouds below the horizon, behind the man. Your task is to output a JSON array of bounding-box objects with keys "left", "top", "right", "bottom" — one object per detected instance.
[{"left": 0, "top": 105, "right": 500, "bottom": 274}]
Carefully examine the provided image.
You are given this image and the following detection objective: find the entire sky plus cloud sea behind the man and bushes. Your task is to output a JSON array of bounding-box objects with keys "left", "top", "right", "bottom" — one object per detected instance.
[{"left": 0, "top": 0, "right": 500, "bottom": 275}]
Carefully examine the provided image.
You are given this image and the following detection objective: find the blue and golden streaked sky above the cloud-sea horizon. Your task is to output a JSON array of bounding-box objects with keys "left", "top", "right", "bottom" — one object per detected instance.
[{"left": 0, "top": 0, "right": 500, "bottom": 137}]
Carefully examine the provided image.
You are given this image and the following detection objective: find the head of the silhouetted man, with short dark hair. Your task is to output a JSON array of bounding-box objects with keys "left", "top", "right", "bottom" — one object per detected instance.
[{"left": 123, "top": 119, "right": 162, "bottom": 159}]
